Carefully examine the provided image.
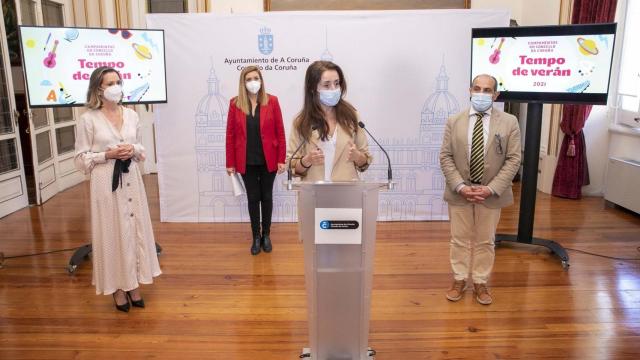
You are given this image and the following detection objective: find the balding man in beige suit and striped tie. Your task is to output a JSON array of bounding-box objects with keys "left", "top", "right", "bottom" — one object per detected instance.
[{"left": 440, "top": 75, "right": 521, "bottom": 305}]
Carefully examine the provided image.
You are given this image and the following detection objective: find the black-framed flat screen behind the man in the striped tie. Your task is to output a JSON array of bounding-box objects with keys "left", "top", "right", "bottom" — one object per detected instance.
[{"left": 471, "top": 23, "right": 616, "bottom": 105}]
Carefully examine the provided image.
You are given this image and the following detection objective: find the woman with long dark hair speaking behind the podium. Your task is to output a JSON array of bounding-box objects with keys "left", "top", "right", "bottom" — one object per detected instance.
[{"left": 287, "top": 61, "right": 372, "bottom": 181}]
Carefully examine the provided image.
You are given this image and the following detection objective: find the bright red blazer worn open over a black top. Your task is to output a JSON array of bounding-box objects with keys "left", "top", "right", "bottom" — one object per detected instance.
[{"left": 226, "top": 95, "right": 287, "bottom": 174}]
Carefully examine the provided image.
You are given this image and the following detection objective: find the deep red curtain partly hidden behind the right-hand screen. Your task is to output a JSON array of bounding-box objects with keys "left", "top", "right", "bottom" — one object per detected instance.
[{"left": 551, "top": 0, "right": 618, "bottom": 199}]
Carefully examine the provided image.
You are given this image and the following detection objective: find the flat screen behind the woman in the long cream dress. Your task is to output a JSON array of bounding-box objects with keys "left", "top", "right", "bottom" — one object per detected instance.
[{"left": 20, "top": 26, "right": 167, "bottom": 108}]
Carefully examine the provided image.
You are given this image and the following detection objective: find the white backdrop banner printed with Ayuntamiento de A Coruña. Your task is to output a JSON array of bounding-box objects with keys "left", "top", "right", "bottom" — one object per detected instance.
[{"left": 147, "top": 10, "right": 509, "bottom": 222}]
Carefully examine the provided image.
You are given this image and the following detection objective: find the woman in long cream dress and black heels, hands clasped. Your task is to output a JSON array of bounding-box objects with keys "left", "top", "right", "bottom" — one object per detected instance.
[{"left": 75, "top": 67, "right": 161, "bottom": 312}]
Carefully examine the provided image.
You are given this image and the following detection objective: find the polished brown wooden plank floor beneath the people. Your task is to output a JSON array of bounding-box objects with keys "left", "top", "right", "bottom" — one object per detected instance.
[{"left": 0, "top": 176, "right": 640, "bottom": 360}]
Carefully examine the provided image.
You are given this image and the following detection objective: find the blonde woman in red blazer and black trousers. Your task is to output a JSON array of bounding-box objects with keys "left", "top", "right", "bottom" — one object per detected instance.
[{"left": 226, "top": 66, "right": 287, "bottom": 255}]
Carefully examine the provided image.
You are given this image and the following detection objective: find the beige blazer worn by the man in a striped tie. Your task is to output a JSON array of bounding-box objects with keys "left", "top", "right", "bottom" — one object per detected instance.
[{"left": 440, "top": 108, "right": 521, "bottom": 209}]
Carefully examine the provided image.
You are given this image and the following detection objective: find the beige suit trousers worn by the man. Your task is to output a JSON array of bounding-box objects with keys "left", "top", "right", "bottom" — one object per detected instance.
[{"left": 449, "top": 203, "right": 500, "bottom": 284}]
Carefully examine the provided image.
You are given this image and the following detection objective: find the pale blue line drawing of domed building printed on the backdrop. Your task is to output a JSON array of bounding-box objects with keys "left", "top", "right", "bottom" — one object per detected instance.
[{"left": 194, "top": 54, "right": 460, "bottom": 222}]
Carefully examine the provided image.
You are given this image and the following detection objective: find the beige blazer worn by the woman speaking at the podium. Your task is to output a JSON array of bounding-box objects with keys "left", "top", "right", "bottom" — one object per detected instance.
[{"left": 287, "top": 124, "right": 373, "bottom": 181}]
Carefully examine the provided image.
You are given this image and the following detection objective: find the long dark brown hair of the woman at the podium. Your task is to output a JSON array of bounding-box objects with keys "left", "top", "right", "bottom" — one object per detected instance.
[{"left": 294, "top": 61, "right": 358, "bottom": 141}]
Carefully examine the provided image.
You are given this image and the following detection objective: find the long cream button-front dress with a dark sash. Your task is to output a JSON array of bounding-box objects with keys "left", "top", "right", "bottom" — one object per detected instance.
[{"left": 75, "top": 107, "right": 162, "bottom": 295}]
